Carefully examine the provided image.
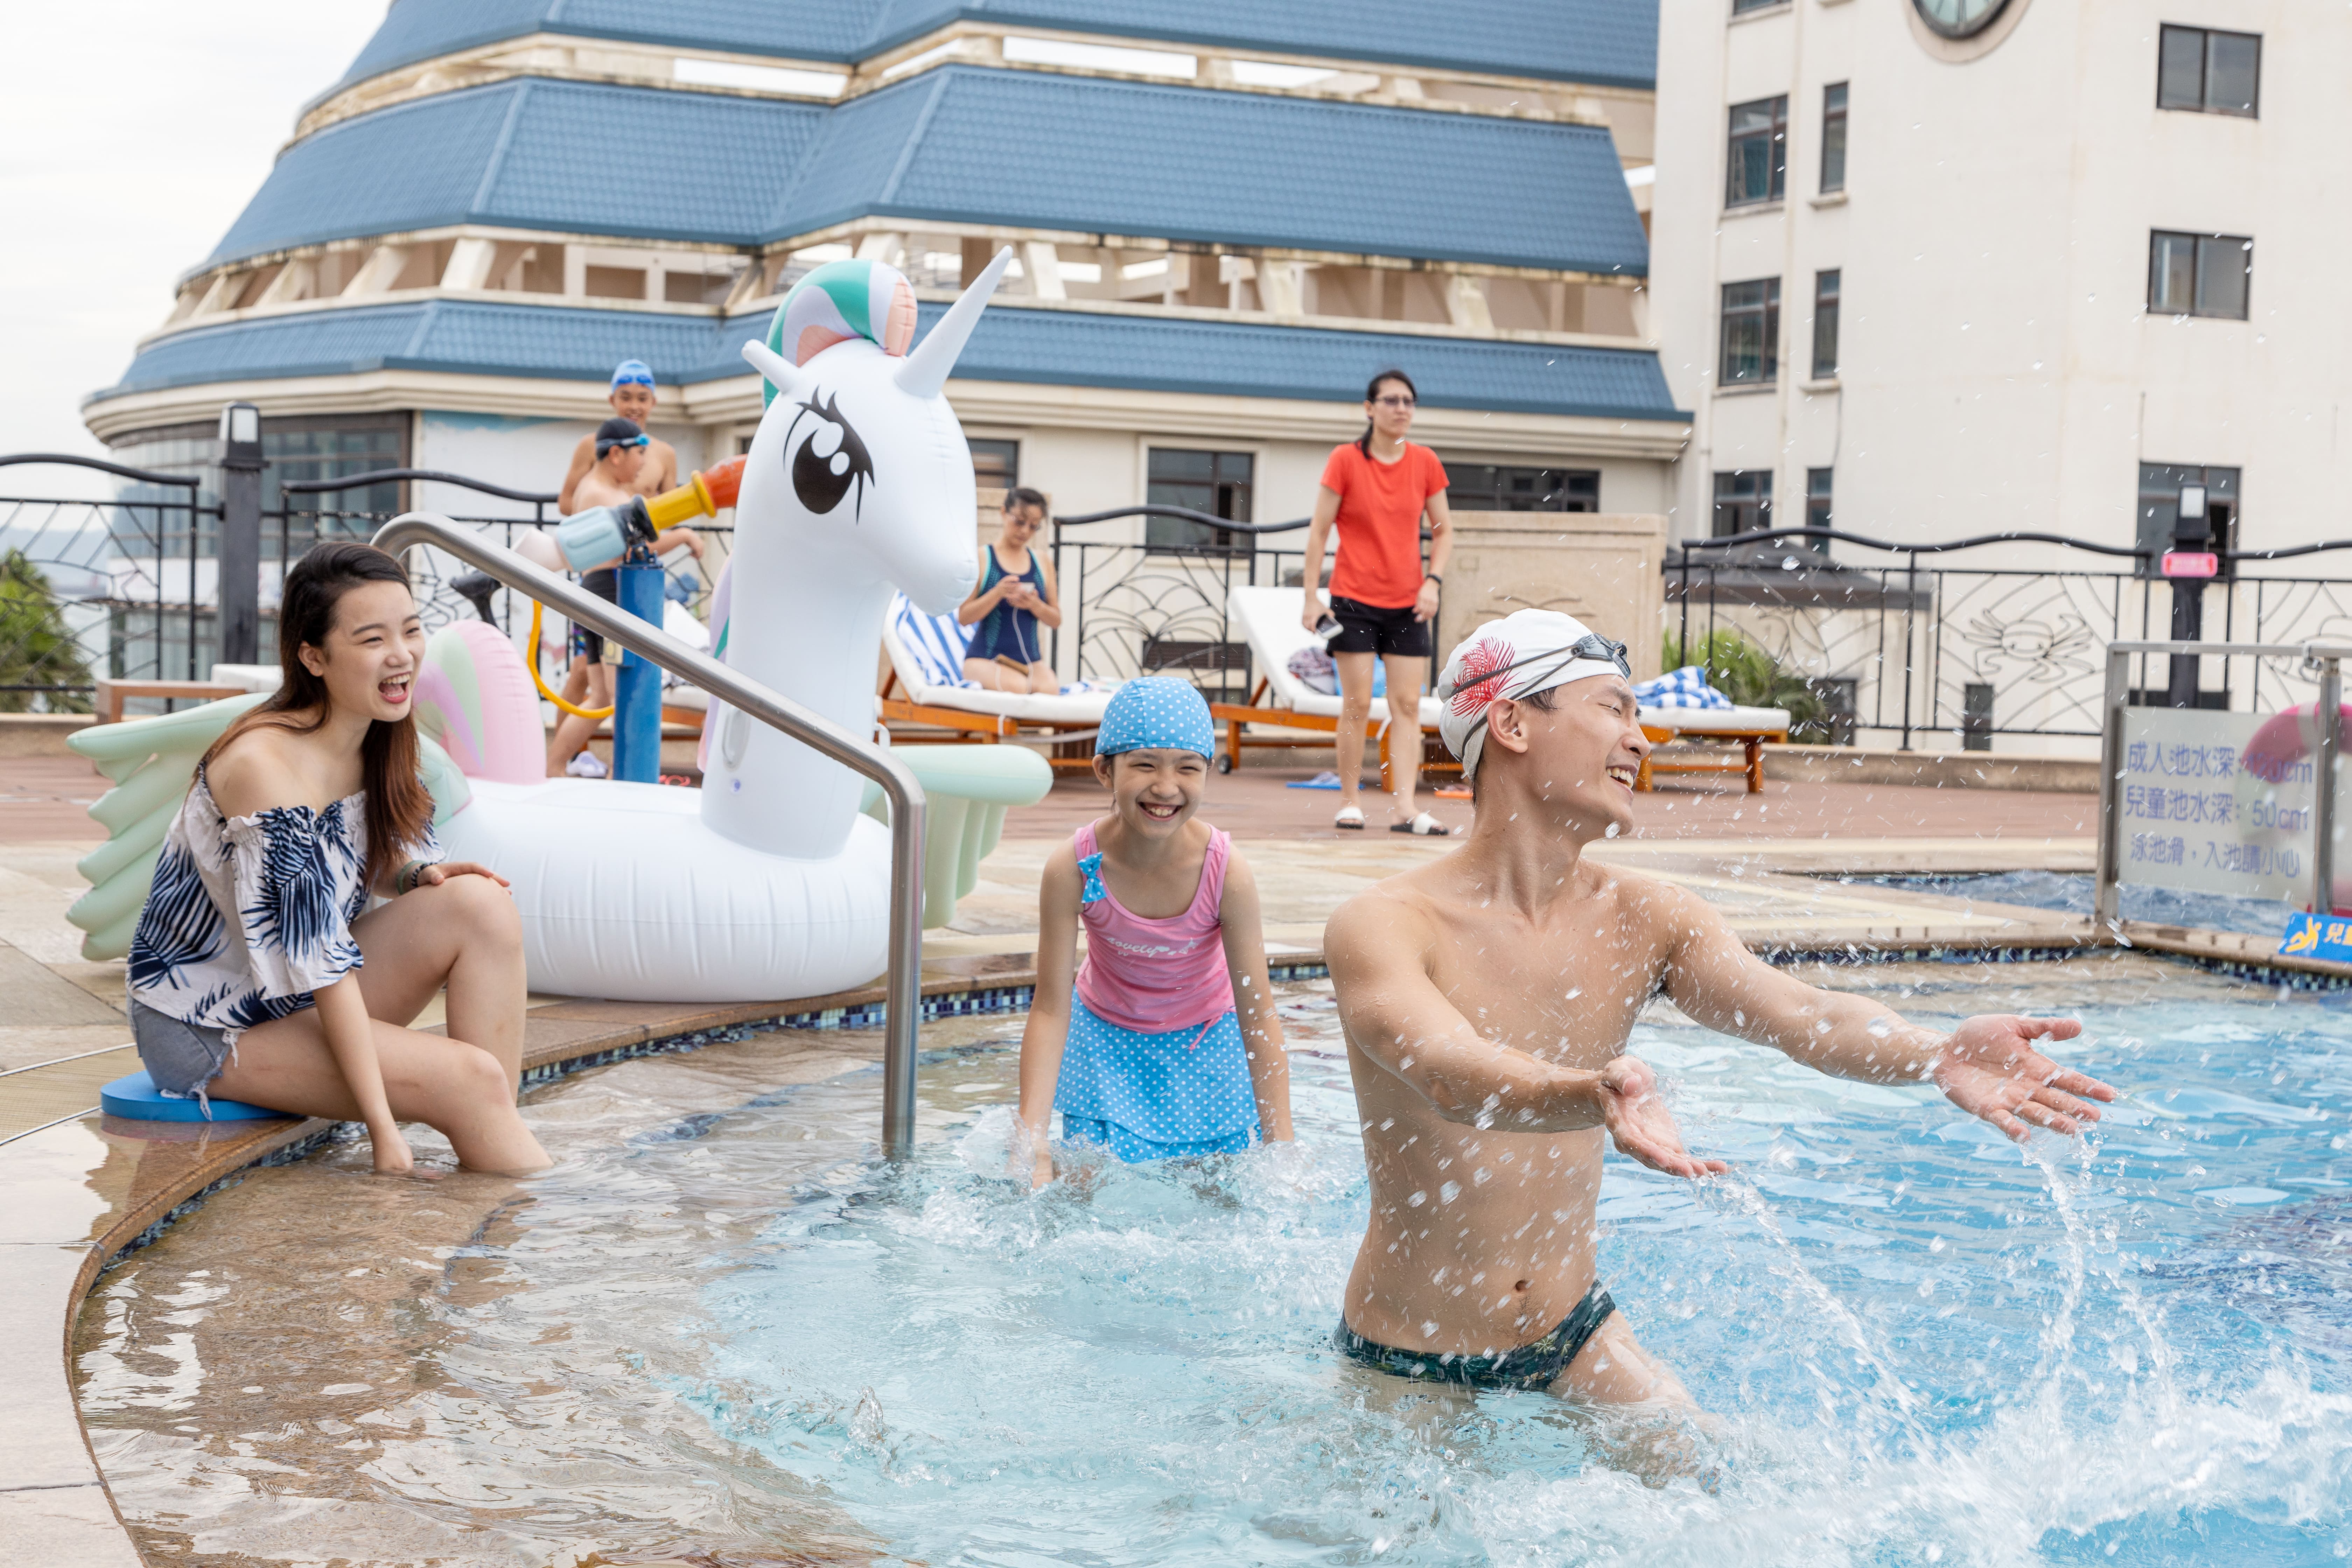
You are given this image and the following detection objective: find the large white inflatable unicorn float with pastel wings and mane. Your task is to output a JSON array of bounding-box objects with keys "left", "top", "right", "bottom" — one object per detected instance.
[{"left": 68, "top": 252, "right": 1051, "bottom": 1001}]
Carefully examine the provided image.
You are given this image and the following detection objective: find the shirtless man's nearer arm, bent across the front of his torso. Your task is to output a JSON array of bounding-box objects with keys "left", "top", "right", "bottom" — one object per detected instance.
[{"left": 1324, "top": 893, "right": 1724, "bottom": 1175}]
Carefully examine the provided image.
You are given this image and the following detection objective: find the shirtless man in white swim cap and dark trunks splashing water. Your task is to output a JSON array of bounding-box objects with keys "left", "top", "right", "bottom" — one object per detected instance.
[{"left": 1324, "top": 609, "right": 2114, "bottom": 1410}]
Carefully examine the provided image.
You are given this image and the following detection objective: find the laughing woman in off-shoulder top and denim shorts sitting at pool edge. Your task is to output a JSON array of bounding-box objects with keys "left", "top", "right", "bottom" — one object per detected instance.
[{"left": 130, "top": 543, "right": 548, "bottom": 1173}]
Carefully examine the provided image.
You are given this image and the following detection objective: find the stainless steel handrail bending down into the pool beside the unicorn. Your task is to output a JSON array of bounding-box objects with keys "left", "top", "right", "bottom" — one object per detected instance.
[{"left": 374, "top": 512, "right": 927, "bottom": 1159}]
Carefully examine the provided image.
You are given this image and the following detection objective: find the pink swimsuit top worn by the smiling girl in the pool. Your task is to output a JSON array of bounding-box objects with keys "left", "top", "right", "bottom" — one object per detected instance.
[{"left": 1075, "top": 823, "right": 1232, "bottom": 1034}]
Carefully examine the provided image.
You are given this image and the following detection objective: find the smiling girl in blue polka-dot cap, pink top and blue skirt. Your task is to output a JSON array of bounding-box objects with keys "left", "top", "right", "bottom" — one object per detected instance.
[{"left": 1011, "top": 677, "right": 1291, "bottom": 1187}]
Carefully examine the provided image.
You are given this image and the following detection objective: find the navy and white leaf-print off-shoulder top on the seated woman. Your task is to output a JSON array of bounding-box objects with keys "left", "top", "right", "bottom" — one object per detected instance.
[{"left": 130, "top": 769, "right": 442, "bottom": 1046}]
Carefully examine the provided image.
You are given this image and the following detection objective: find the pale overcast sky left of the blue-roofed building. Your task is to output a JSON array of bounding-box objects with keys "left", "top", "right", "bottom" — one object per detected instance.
[{"left": 0, "top": 0, "right": 383, "bottom": 493}]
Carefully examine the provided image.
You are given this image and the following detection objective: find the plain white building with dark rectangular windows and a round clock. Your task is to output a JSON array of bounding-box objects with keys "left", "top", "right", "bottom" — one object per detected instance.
[{"left": 1651, "top": 0, "right": 2352, "bottom": 745}]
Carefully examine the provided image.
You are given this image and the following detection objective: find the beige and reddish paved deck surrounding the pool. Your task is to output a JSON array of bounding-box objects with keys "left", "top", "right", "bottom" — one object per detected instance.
[{"left": 0, "top": 757, "right": 2314, "bottom": 1568}]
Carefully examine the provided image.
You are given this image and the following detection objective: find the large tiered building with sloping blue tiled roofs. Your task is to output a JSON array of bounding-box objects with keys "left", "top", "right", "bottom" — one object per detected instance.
[{"left": 85, "top": 0, "right": 1689, "bottom": 677}]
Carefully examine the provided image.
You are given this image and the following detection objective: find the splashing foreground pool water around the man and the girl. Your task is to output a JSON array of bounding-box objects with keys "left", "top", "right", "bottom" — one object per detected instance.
[{"left": 80, "top": 957, "right": 2352, "bottom": 1568}]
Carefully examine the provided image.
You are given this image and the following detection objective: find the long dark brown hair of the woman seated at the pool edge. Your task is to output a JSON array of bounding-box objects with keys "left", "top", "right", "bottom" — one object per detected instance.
[{"left": 205, "top": 543, "right": 433, "bottom": 889}]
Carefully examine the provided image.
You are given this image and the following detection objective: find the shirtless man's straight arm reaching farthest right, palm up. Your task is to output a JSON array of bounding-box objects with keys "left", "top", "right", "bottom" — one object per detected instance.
[{"left": 1660, "top": 889, "right": 2114, "bottom": 1142}]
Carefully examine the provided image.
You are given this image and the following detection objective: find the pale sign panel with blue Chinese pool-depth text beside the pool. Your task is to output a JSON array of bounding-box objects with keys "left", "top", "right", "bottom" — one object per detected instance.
[{"left": 2114, "top": 708, "right": 2347, "bottom": 903}]
